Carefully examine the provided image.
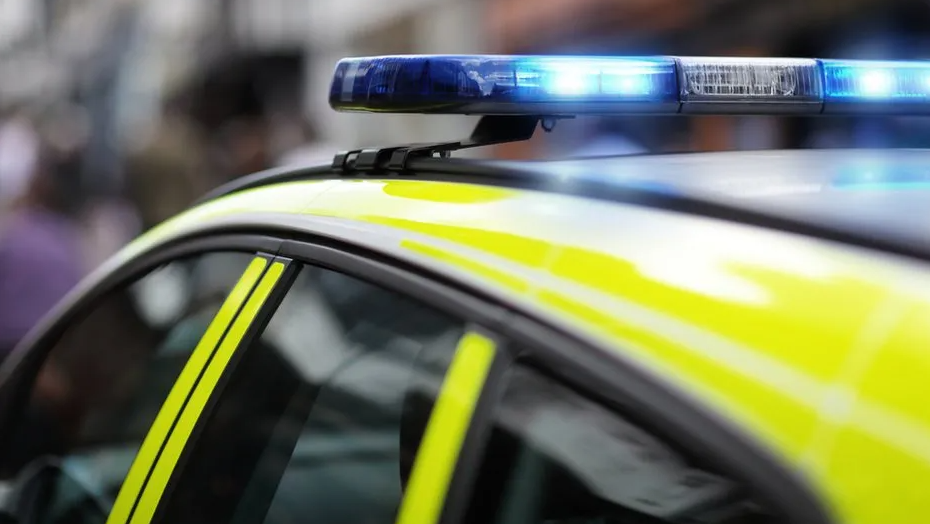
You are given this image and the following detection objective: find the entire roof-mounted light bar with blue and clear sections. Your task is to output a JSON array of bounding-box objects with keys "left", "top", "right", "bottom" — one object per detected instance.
[{"left": 330, "top": 55, "right": 930, "bottom": 116}]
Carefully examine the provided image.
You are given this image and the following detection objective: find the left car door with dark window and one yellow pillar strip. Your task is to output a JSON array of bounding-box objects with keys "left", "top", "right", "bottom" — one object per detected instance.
[{"left": 0, "top": 238, "right": 284, "bottom": 524}]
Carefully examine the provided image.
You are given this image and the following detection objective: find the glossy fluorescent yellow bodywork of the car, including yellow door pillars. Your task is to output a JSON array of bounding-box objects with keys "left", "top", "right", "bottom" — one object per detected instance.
[{"left": 1, "top": 147, "right": 930, "bottom": 524}]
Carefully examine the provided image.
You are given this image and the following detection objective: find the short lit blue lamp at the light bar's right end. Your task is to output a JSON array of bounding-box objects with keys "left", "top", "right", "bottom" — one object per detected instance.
[{"left": 821, "top": 60, "right": 930, "bottom": 113}]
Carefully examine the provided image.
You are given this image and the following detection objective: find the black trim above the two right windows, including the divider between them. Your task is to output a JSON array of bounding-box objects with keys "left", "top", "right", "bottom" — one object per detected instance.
[{"left": 258, "top": 235, "right": 836, "bottom": 524}]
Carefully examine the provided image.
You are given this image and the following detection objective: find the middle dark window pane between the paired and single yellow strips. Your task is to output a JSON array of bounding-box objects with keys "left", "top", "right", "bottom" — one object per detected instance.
[{"left": 156, "top": 266, "right": 464, "bottom": 524}]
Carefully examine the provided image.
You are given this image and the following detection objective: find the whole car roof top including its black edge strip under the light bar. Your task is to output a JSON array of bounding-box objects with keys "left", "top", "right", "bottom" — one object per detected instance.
[{"left": 207, "top": 149, "right": 930, "bottom": 260}]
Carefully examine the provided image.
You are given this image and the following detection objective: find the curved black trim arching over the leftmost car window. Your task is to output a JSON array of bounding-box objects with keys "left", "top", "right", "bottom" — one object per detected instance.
[{"left": 0, "top": 233, "right": 281, "bottom": 450}]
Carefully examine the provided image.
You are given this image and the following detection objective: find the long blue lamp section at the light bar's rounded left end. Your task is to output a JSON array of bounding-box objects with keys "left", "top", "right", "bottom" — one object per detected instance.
[{"left": 330, "top": 56, "right": 678, "bottom": 115}]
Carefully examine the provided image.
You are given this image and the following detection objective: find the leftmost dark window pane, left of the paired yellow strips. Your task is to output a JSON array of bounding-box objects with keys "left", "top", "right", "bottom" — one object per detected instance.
[{"left": 0, "top": 252, "right": 253, "bottom": 524}]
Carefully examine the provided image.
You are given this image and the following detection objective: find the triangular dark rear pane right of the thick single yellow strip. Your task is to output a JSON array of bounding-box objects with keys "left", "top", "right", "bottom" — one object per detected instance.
[{"left": 463, "top": 367, "right": 777, "bottom": 524}]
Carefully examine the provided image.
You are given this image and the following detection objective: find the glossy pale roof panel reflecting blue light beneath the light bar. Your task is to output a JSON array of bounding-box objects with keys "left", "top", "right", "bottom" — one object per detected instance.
[{"left": 493, "top": 149, "right": 930, "bottom": 252}]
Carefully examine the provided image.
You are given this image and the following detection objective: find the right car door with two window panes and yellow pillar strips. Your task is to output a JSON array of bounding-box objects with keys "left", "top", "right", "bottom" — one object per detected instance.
[{"left": 98, "top": 235, "right": 827, "bottom": 524}]
